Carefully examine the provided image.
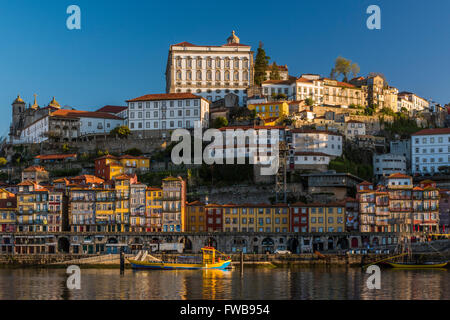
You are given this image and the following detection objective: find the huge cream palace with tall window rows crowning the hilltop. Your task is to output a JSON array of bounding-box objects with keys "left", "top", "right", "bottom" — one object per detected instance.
[{"left": 166, "top": 31, "right": 253, "bottom": 106}]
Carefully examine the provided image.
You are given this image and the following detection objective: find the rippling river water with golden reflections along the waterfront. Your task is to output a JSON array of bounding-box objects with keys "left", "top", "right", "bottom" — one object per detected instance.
[{"left": 0, "top": 267, "right": 450, "bottom": 300}]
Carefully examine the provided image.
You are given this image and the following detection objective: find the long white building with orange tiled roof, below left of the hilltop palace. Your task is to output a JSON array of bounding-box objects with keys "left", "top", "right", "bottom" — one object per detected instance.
[{"left": 127, "top": 93, "right": 210, "bottom": 131}]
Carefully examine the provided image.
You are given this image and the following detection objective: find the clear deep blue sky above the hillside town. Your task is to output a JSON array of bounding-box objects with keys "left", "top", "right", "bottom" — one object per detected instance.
[{"left": 0, "top": 0, "right": 450, "bottom": 136}]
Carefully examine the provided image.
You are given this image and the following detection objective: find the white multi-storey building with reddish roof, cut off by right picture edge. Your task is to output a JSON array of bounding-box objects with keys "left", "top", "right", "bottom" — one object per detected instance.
[{"left": 411, "top": 128, "right": 450, "bottom": 174}]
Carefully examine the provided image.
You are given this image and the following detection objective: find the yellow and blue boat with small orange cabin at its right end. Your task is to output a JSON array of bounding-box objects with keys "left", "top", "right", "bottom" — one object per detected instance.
[{"left": 128, "top": 247, "right": 231, "bottom": 270}]
